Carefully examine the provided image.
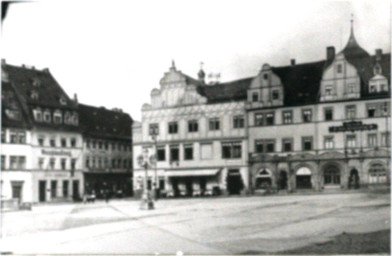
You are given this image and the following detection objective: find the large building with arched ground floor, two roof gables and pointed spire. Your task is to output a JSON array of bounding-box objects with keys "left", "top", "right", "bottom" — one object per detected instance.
[{"left": 246, "top": 24, "right": 391, "bottom": 191}]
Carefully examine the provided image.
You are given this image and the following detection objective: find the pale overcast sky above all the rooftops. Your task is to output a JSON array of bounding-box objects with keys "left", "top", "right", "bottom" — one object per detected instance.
[{"left": 1, "top": 0, "right": 391, "bottom": 120}]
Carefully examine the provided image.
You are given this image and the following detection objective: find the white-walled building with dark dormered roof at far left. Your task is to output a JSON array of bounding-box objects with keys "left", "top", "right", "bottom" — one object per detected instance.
[{"left": 1, "top": 61, "right": 83, "bottom": 202}]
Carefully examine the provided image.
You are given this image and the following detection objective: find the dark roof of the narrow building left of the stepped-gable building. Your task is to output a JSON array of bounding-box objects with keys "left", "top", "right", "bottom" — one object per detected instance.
[{"left": 79, "top": 104, "right": 133, "bottom": 140}]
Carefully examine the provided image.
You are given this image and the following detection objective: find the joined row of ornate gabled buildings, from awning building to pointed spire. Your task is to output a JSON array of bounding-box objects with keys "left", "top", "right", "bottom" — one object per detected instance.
[{"left": 133, "top": 23, "right": 391, "bottom": 196}]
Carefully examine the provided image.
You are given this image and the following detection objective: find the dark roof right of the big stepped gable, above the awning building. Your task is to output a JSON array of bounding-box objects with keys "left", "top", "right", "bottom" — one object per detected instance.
[{"left": 197, "top": 77, "right": 253, "bottom": 103}]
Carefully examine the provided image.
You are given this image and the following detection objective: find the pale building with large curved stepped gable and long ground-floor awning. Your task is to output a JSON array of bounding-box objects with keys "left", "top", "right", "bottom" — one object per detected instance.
[{"left": 133, "top": 63, "right": 249, "bottom": 196}]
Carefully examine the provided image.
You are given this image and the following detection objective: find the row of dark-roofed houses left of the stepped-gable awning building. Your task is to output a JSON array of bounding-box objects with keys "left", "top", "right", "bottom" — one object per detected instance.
[{"left": 1, "top": 60, "right": 133, "bottom": 202}]
